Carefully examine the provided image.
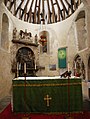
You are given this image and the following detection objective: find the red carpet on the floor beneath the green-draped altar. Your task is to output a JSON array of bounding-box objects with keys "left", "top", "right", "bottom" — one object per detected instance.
[{"left": 0, "top": 104, "right": 90, "bottom": 119}]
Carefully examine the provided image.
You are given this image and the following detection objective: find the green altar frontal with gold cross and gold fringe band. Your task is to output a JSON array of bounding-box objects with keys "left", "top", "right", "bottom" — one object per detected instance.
[{"left": 12, "top": 77, "right": 82, "bottom": 113}]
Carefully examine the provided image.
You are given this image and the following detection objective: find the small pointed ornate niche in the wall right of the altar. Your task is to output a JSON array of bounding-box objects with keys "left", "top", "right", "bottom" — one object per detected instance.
[{"left": 73, "top": 55, "right": 85, "bottom": 79}]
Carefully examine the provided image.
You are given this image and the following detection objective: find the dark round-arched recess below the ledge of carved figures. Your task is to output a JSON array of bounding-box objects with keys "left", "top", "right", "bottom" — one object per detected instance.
[{"left": 16, "top": 47, "right": 35, "bottom": 77}]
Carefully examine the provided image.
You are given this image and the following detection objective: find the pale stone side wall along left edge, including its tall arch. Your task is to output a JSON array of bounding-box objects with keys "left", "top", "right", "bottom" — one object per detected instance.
[{"left": 0, "top": 1, "right": 14, "bottom": 98}]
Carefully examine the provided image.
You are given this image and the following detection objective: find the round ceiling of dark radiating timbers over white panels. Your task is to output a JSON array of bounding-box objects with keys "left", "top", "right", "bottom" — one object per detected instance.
[{"left": 4, "top": 0, "right": 81, "bottom": 24}]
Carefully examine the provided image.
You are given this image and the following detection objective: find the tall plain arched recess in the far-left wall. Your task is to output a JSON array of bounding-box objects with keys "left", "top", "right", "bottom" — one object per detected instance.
[{"left": 1, "top": 13, "right": 9, "bottom": 50}]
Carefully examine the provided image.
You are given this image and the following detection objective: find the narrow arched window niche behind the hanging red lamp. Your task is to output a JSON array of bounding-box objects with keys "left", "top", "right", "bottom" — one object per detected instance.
[{"left": 39, "top": 31, "right": 49, "bottom": 53}]
